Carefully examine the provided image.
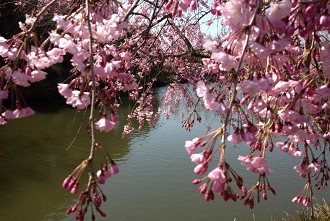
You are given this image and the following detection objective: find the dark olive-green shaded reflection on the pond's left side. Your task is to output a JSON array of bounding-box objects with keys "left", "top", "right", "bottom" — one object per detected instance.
[{"left": 0, "top": 98, "right": 135, "bottom": 221}]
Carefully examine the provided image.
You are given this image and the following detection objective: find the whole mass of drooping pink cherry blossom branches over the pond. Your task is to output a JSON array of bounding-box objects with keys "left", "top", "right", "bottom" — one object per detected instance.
[{"left": 0, "top": 0, "right": 330, "bottom": 220}]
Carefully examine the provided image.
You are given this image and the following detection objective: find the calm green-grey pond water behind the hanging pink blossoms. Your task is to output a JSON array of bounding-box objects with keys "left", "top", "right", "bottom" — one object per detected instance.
[{"left": 0, "top": 88, "right": 330, "bottom": 221}]
